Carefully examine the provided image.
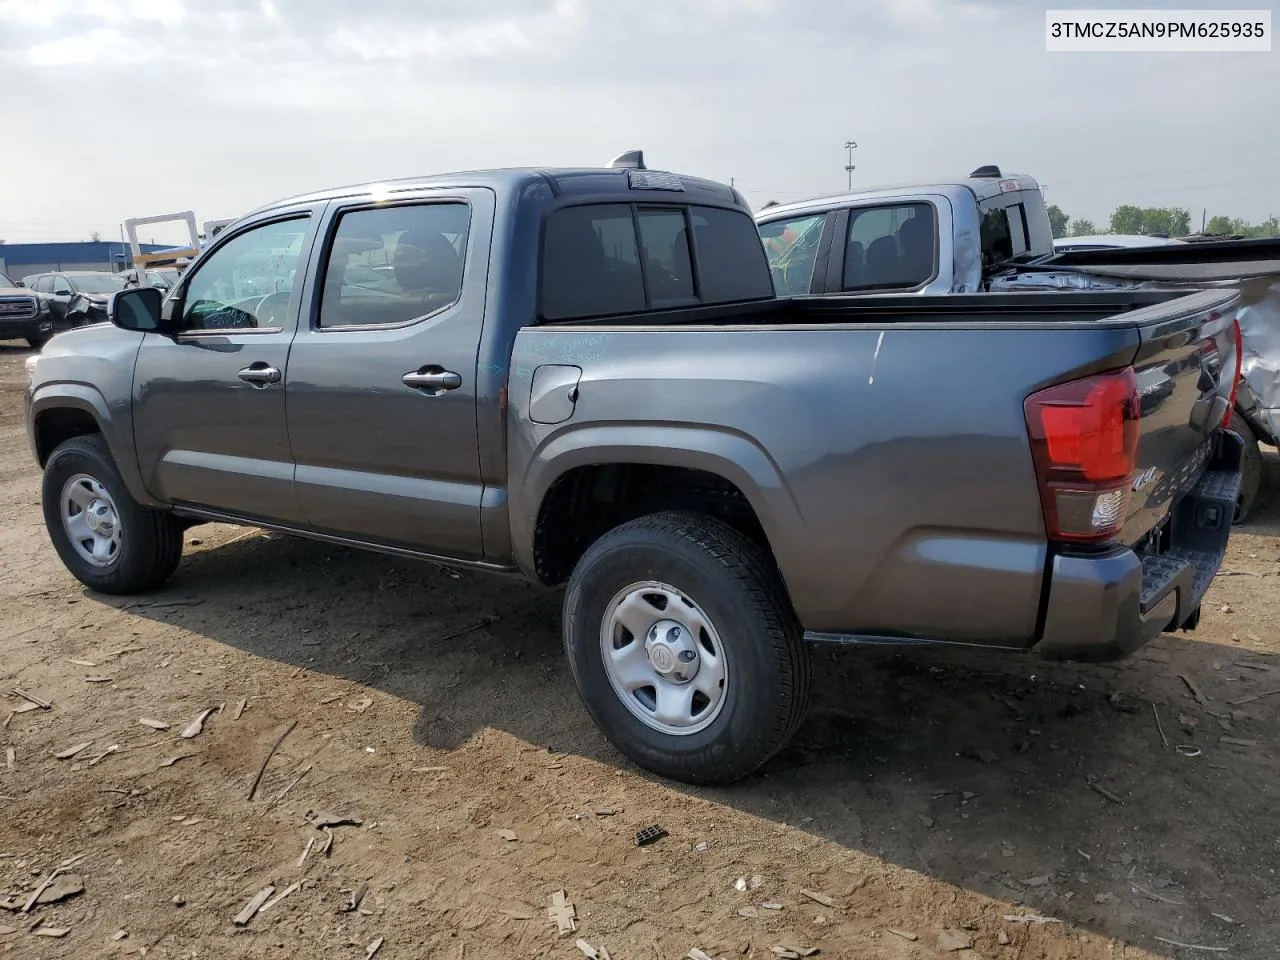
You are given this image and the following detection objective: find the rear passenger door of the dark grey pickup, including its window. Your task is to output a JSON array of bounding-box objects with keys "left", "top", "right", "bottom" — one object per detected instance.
[{"left": 287, "top": 189, "right": 494, "bottom": 559}]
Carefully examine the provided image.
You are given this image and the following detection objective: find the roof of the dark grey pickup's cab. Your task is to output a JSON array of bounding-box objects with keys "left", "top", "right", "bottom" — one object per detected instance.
[{"left": 248, "top": 166, "right": 750, "bottom": 216}]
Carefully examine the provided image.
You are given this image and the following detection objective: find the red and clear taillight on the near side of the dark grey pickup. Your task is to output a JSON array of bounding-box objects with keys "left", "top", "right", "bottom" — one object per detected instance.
[{"left": 1023, "top": 367, "right": 1139, "bottom": 541}]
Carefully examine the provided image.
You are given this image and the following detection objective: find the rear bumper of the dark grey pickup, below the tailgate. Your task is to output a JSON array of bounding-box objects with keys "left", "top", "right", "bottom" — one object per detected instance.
[{"left": 1033, "top": 430, "right": 1244, "bottom": 660}]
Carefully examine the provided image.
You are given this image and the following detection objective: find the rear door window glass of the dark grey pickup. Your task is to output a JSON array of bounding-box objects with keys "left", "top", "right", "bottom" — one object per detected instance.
[{"left": 317, "top": 202, "right": 471, "bottom": 328}]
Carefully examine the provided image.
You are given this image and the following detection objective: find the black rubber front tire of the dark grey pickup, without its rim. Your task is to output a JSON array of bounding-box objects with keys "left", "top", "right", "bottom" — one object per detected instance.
[{"left": 41, "top": 434, "right": 182, "bottom": 595}]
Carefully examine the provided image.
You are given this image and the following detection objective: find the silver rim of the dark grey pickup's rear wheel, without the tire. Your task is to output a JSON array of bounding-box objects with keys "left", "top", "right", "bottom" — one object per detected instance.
[{"left": 600, "top": 580, "right": 728, "bottom": 736}]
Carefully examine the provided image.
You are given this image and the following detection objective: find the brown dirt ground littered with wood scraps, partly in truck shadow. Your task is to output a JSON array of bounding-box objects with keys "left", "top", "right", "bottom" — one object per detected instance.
[{"left": 0, "top": 346, "right": 1280, "bottom": 960}]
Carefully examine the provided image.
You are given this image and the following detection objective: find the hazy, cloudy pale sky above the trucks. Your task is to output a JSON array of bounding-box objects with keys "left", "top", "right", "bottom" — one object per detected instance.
[{"left": 0, "top": 0, "right": 1280, "bottom": 243}]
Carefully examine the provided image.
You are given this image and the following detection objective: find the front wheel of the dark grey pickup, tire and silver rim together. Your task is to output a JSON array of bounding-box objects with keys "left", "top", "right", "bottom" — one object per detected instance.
[{"left": 41, "top": 434, "right": 182, "bottom": 594}]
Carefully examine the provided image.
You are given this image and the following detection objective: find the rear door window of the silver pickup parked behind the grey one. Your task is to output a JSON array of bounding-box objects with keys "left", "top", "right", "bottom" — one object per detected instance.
[{"left": 844, "top": 202, "right": 938, "bottom": 291}]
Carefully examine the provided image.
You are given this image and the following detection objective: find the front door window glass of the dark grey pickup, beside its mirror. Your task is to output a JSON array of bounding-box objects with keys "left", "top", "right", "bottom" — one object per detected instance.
[{"left": 182, "top": 218, "right": 307, "bottom": 330}]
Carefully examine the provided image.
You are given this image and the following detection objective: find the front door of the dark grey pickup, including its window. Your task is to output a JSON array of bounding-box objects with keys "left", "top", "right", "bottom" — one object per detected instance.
[{"left": 133, "top": 209, "right": 319, "bottom": 525}]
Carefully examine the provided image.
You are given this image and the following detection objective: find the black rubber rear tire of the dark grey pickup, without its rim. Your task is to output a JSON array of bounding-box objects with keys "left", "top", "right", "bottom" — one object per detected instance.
[{"left": 563, "top": 512, "right": 810, "bottom": 785}]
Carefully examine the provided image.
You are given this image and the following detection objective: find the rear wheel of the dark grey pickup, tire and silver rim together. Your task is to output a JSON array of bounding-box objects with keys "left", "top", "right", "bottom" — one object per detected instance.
[{"left": 564, "top": 512, "right": 810, "bottom": 785}]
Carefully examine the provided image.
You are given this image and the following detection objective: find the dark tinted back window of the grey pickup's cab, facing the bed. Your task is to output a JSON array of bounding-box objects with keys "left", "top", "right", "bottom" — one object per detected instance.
[{"left": 541, "top": 204, "right": 773, "bottom": 320}]
